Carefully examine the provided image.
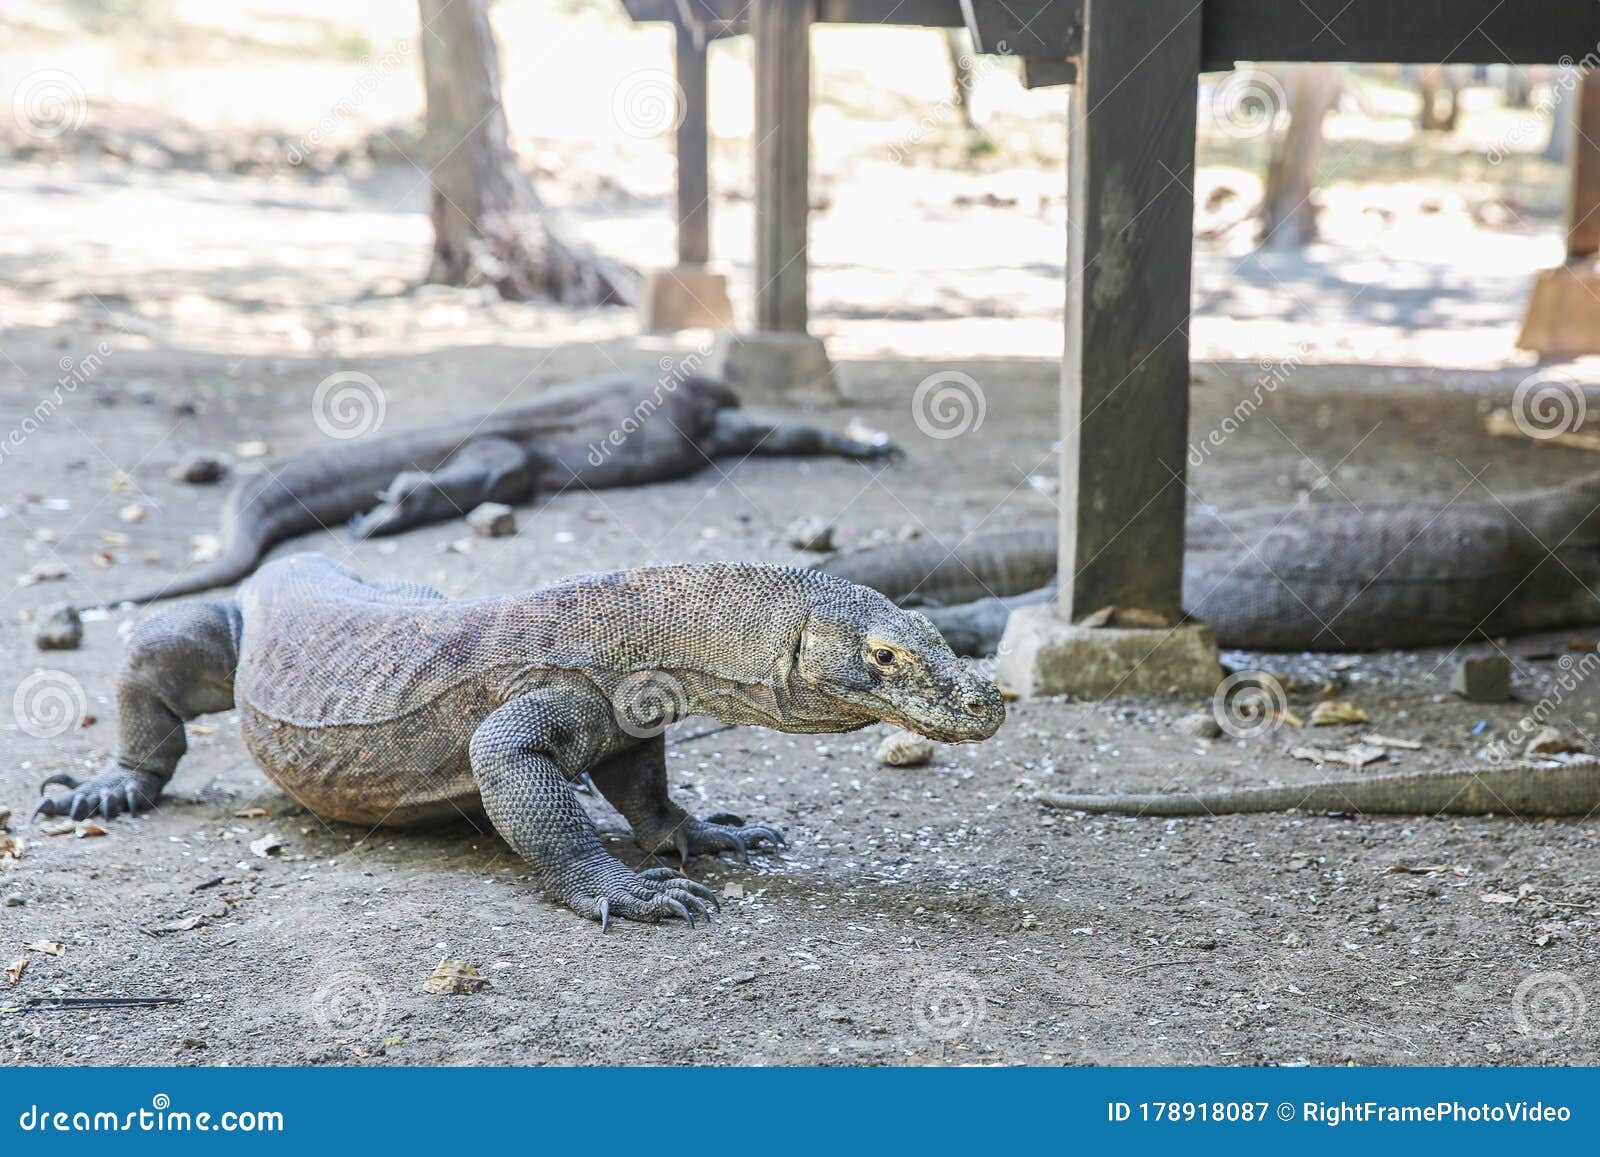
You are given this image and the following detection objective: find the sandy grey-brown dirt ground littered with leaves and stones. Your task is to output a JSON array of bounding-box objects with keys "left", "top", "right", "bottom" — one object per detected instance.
[{"left": 0, "top": 0, "right": 1600, "bottom": 1064}]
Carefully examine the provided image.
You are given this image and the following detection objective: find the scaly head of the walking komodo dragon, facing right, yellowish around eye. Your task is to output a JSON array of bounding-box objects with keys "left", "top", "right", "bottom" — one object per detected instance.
[{"left": 795, "top": 579, "right": 1005, "bottom": 743}]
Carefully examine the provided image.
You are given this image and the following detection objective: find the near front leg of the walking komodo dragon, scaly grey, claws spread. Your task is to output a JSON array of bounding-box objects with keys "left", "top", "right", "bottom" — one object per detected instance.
[{"left": 469, "top": 691, "right": 717, "bottom": 927}]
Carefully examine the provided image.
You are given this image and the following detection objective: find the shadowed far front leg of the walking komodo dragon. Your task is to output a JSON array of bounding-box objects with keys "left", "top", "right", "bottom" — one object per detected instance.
[{"left": 590, "top": 735, "right": 784, "bottom": 864}]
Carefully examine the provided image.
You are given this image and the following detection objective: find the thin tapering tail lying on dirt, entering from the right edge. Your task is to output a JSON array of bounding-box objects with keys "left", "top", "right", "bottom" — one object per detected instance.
[{"left": 1034, "top": 759, "right": 1600, "bottom": 818}]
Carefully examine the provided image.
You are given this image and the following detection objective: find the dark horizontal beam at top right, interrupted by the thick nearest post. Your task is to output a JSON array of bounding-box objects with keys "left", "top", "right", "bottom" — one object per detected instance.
[{"left": 962, "top": 0, "right": 1600, "bottom": 70}]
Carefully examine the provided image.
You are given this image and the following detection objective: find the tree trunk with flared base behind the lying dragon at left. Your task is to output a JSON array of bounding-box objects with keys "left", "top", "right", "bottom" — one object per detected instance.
[{"left": 421, "top": 0, "right": 634, "bottom": 304}]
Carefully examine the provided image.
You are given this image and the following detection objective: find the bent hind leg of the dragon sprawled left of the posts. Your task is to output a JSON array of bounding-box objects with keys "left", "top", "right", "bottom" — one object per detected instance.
[{"left": 350, "top": 438, "right": 542, "bottom": 538}]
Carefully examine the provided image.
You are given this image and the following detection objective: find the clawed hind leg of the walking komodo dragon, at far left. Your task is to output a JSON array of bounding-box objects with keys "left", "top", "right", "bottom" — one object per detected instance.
[{"left": 34, "top": 599, "right": 240, "bottom": 819}]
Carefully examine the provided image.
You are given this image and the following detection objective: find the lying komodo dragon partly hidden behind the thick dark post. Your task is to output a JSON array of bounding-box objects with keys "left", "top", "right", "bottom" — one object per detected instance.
[{"left": 821, "top": 474, "right": 1600, "bottom": 655}]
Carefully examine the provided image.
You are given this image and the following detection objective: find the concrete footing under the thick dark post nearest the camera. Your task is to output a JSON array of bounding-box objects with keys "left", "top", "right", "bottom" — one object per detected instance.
[{"left": 995, "top": 603, "right": 1222, "bottom": 696}]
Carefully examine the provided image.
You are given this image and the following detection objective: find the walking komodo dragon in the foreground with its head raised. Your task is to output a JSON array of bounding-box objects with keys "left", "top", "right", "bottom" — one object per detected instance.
[{"left": 38, "top": 554, "right": 1005, "bottom": 925}]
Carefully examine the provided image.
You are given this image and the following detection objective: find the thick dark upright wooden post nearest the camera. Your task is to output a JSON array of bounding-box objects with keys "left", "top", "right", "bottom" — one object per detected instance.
[{"left": 1059, "top": 0, "right": 1200, "bottom": 621}]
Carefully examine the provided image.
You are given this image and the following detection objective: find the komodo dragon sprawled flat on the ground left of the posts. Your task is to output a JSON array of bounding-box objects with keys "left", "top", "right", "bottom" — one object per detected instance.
[{"left": 114, "top": 374, "right": 899, "bottom": 603}]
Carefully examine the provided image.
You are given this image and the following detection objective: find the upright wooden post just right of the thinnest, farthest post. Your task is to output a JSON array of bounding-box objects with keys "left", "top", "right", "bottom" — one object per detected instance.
[{"left": 750, "top": 0, "right": 811, "bottom": 333}]
